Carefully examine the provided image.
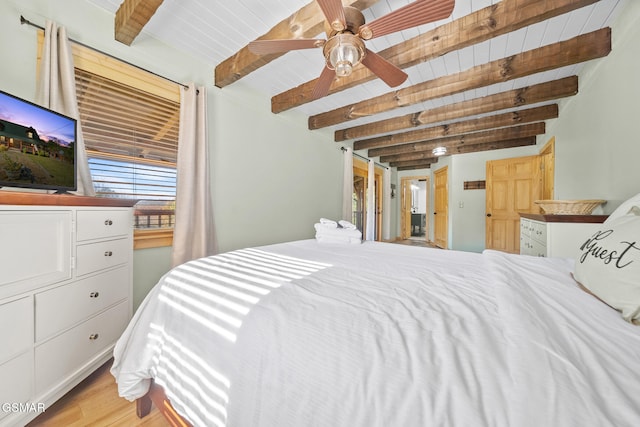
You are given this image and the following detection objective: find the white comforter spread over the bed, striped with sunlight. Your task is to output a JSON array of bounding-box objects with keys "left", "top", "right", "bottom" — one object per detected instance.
[{"left": 112, "top": 240, "right": 640, "bottom": 427}]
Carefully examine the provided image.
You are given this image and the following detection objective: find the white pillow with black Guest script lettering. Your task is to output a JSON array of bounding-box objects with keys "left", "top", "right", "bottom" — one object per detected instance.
[{"left": 574, "top": 206, "right": 640, "bottom": 323}]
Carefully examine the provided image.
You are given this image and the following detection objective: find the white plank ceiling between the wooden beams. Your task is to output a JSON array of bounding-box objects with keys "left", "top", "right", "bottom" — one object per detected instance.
[{"left": 87, "top": 0, "right": 624, "bottom": 152}]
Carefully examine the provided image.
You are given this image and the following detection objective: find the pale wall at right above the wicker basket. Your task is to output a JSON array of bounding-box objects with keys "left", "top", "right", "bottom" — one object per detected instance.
[{"left": 539, "top": 0, "right": 640, "bottom": 213}]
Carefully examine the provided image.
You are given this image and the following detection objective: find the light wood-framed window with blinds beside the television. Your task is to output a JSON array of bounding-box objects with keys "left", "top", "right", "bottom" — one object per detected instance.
[{"left": 39, "top": 32, "right": 180, "bottom": 248}]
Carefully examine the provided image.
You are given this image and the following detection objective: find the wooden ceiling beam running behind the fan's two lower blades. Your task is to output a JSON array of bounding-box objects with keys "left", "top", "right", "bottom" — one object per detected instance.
[{"left": 271, "top": 0, "right": 599, "bottom": 113}]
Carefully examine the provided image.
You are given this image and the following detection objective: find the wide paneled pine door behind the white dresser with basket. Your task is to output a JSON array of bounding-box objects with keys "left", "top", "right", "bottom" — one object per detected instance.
[{"left": 485, "top": 156, "right": 541, "bottom": 253}]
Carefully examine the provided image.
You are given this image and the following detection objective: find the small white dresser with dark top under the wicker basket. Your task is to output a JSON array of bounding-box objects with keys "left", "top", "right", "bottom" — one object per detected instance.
[{"left": 520, "top": 213, "right": 607, "bottom": 258}]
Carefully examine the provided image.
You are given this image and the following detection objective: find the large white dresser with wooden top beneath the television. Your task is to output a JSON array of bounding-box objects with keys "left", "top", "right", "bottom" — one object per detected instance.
[{"left": 0, "top": 192, "right": 134, "bottom": 426}]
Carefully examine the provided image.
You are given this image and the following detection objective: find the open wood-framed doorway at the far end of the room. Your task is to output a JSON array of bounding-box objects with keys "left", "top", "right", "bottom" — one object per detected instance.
[{"left": 400, "top": 176, "right": 429, "bottom": 242}]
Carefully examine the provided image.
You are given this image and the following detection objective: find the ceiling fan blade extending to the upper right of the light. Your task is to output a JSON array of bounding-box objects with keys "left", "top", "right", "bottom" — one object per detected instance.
[{"left": 360, "top": 0, "right": 455, "bottom": 40}]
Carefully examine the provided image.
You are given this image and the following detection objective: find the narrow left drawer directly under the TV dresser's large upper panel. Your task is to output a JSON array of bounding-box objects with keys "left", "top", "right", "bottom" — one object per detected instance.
[{"left": 0, "top": 295, "right": 33, "bottom": 364}]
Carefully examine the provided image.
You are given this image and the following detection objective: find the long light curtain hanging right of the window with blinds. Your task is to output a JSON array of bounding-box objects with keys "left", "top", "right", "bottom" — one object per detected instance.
[{"left": 172, "top": 83, "right": 216, "bottom": 266}]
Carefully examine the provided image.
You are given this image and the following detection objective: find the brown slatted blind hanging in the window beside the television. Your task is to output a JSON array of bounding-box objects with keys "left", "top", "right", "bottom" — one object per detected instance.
[{"left": 75, "top": 68, "right": 180, "bottom": 228}]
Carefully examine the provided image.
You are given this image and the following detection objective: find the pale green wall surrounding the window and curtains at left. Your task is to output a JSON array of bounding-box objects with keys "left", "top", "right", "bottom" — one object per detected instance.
[{"left": 0, "top": 0, "right": 342, "bottom": 306}]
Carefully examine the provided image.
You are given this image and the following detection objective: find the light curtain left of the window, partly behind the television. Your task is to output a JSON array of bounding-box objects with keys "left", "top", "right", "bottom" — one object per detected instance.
[{"left": 36, "top": 21, "right": 96, "bottom": 196}]
